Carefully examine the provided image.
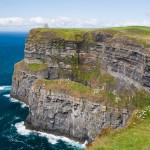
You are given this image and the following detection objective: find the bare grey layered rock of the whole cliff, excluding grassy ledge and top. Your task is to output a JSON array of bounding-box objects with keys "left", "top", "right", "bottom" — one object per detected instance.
[{"left": 11, "top": 30, "right": 150, "bottom": 141}]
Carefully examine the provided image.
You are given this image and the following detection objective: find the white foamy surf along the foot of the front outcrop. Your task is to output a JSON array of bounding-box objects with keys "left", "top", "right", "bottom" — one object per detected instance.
[{"left": 15, "top": 121, "right": 87, "bottom": 148}]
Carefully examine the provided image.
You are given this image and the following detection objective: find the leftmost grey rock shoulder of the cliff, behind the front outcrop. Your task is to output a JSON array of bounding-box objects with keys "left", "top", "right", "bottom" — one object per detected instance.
[{"left": 11, "top": 60, "right": 48, "bottom": 104}]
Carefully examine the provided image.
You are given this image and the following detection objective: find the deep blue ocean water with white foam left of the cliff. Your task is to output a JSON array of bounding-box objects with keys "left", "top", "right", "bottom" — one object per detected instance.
[{"left": 0, "top": 32, "right": 83, "bottom": 150}]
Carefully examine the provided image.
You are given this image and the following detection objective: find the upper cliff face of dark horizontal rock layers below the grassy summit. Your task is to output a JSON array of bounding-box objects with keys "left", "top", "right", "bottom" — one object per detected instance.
[{"left": 25, "top": 31, "right": 150, "bottom": 91}]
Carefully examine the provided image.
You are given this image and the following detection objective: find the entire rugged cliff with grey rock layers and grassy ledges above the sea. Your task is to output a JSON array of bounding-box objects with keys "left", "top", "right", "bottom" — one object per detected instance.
[{"left": 11, "top": 29, "right": 150, "bottom": 144}]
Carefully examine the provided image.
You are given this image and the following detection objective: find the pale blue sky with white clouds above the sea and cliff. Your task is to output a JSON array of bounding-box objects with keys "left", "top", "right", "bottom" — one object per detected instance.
[{"left": 0, "top": 0, "right": 150, "bottom": 31}]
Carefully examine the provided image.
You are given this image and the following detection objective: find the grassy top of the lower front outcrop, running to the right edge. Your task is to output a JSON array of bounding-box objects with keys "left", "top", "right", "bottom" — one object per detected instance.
[{"left": 33, "top": 79, "right": 150, "bottom": 109}]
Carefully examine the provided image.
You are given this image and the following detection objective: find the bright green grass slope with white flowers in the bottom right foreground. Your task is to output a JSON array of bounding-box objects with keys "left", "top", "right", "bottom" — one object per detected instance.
[{"left": 87, "top": 106, "right": 150, "bottom": 150}]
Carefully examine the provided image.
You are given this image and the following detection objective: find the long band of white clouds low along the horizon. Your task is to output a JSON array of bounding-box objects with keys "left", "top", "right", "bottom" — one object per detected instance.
[{"left": 0, "top": 17, "right": 150, "bottom": 29}]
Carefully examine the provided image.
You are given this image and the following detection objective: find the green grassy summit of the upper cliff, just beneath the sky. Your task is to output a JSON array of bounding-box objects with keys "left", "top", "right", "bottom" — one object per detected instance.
[{"left": 29, "top": 26, "right": 150, "bottom": 47}]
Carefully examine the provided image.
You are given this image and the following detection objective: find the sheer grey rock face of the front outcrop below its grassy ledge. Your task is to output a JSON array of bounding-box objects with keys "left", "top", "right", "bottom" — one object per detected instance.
[{"left": 27, "top": 81, "right": 130, "bottom": 142}]
